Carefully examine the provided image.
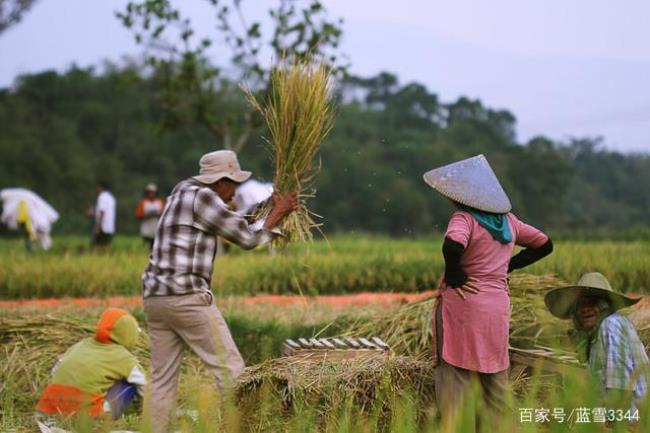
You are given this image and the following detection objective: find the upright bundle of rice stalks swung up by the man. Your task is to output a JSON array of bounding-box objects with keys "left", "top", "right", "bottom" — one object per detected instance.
[{"left": 245, "top": 59, "right": 334, "bottom": 245}]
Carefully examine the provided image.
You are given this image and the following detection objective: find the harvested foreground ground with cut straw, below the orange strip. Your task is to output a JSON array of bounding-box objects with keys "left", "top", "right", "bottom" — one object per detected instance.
[{"left": 0, "top": 282, "right": 650, "bottom": 433}]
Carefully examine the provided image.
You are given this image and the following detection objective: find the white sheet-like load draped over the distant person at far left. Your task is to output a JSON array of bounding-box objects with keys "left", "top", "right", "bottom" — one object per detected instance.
[{"left": 0, "top": 188, "right": 59, "bottom": 249}]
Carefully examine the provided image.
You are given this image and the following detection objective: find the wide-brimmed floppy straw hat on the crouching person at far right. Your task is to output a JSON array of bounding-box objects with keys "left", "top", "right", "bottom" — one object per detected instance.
[{"left": 544, "top": 272, "right": 641, "bottom": 319}]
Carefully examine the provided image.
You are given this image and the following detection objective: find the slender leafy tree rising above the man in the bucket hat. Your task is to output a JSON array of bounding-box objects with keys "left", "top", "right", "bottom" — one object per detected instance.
[{"left": 117, "top": 0, "right": 345, "bottom": 151}]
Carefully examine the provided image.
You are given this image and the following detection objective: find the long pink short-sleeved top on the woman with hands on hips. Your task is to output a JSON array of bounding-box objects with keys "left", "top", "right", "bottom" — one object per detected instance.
[{"left": 440, "top": 211, "right": 548, "bottom": 373}]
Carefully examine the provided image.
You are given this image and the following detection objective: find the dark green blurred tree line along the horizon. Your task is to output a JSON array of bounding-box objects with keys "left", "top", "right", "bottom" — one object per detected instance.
[{"left": 0, "top": 64, "right": 650, "bottom": 236}]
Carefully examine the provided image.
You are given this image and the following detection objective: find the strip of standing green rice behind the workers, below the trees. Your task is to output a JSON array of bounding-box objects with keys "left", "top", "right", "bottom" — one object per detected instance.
[{"left": 0, "top": 237, "right": 650, "bottom": 299}]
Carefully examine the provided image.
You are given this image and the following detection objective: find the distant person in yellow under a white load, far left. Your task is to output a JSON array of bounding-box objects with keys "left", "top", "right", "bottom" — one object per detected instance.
[{"left": 0, "top": 188, "right": 59, "bottom": 251}]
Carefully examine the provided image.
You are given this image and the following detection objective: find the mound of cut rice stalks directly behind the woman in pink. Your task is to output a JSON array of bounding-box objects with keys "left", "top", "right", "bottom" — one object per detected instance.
[{"left": 344, "top": 274, "right": 568, "bottom": 356}]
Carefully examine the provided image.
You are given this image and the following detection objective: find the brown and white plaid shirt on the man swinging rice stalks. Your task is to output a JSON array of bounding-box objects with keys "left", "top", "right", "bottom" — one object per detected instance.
[{"left": 142, "top": 179, "right": 275, "bottom": 298}]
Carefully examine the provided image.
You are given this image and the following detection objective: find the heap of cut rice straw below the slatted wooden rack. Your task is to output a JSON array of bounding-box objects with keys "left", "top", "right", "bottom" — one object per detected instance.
[{"left": 237, "top": 356, "right": 434, "bottom": 423}]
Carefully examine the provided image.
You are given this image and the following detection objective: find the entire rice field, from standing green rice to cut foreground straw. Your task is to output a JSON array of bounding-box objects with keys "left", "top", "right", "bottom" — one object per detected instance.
[{"left": 0, "top": 237, "right": 650, "bottom": 433}]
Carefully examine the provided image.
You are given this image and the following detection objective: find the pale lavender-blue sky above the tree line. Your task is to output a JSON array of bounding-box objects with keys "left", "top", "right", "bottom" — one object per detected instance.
[{"left": 0, "top": 0, "right": 650, "bottom": 153}]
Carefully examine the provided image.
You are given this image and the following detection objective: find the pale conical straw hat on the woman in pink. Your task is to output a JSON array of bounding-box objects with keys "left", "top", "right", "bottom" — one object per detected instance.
[{"left": 424, "top": 155, "right": 512, "bottom": 214}]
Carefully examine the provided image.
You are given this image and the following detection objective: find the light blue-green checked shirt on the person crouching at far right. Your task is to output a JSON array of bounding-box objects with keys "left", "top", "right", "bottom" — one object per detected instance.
[{"left": 589, "top": 313, "right": 650, "bottom": 402}]
